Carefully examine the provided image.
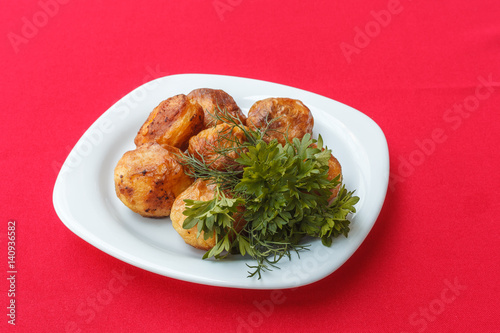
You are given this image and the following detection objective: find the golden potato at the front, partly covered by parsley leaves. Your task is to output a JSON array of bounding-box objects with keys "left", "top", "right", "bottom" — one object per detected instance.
[{"left": 170, "top": 179, "right": 245, "bottom": 251}]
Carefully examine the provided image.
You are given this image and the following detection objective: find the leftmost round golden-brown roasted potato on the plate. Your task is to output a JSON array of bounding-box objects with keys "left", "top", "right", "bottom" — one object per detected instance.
[{"left": 114, "top": 142, "right": 193, "bottom": 217}]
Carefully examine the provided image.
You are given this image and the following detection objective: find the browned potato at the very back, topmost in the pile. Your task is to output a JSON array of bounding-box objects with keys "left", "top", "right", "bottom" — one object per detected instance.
[{"left": 188, "top": 88, "right": 246, "bottom": 128}]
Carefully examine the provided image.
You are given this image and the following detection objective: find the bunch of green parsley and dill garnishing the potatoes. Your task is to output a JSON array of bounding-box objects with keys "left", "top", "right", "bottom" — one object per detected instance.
[{"left": 178, "top": 107, "right": 359, "bottom": 279}]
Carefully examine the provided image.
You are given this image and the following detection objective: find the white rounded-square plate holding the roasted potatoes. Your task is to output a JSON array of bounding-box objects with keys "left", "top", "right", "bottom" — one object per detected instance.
[{"left": 53, "top": 74, "right": 389, "bottom": 289}]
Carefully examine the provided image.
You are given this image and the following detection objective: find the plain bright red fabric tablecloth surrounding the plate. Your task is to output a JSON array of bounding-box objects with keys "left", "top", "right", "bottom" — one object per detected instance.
[{"left": 0, "top": 0, "right": 500, "bottom": 332}]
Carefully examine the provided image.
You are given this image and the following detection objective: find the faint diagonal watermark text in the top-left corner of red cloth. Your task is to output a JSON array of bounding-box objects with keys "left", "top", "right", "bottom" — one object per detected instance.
[{"left": 7, "top": 0, "right": 70, "bottom": 53}]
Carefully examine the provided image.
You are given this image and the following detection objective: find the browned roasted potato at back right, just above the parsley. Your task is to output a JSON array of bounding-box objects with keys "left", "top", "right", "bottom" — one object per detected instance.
[{"left": 246, "top": 98, "right": 314, "bottom": 145}]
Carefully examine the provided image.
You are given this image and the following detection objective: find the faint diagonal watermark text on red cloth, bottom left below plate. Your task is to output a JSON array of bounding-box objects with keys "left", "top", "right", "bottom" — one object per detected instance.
[{"left": 64, "top": 269, "right": 135, "bottom": 333}]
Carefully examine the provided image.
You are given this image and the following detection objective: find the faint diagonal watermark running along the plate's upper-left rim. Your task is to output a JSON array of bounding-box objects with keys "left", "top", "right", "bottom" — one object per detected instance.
[{"left": 52, "top": 65, "right": 167, "bottom": 175}]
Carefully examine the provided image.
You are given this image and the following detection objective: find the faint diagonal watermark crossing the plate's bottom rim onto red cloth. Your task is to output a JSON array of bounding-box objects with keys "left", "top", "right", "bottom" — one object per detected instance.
[{"left": 236, "top": 245, "right": 335, "bottom": 333}]
